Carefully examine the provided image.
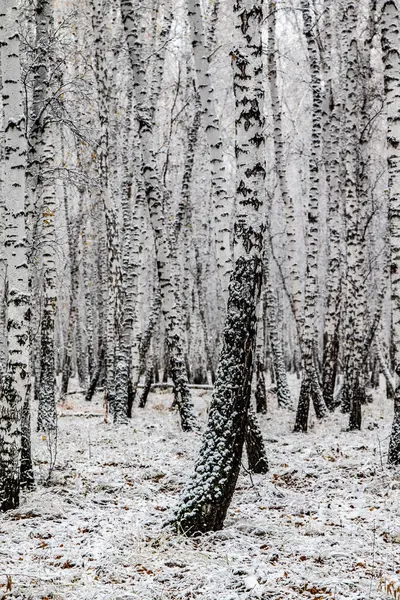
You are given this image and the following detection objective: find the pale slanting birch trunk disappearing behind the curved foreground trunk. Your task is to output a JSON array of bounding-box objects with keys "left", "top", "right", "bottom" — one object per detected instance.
[{"left": 188, "top": 0, "right": 232, "bottom": 304}]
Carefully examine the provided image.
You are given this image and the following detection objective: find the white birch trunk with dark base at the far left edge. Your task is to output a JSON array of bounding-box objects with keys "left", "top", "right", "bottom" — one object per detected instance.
[{"left": 0, "top": 0, "right": 30, "bottom": 511}]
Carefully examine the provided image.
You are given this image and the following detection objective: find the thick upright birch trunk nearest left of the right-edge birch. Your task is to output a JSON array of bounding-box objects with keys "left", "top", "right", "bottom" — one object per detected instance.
[{"left": 343, "top": 2, "right": 371, "bottom": 429}]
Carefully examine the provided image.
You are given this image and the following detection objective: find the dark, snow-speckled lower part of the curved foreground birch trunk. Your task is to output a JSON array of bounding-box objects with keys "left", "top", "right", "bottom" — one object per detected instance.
[{"left": 172, "top": 259, "right": 261, "bottom": 535}]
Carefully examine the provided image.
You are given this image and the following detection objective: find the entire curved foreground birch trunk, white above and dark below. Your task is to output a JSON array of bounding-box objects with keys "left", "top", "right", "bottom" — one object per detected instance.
[{"left": 174, "top": 0, "right": 265, "bottom": 535}]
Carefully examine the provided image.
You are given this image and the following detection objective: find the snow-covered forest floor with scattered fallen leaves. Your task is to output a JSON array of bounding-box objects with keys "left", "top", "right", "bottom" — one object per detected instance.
[{"left": 0, "top": 381, "right": 400, "bottom": 600}]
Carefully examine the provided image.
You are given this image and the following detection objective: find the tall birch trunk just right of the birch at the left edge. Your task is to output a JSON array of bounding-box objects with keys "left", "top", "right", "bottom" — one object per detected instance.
[{"left": 28, "top": 0, "right": 57, "bottom": 431}]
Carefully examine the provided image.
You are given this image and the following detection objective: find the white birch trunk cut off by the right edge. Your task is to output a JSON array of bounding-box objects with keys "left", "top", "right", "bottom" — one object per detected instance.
[{"left": 381, "top": 0, "right": 400, "bottom": 465}]
